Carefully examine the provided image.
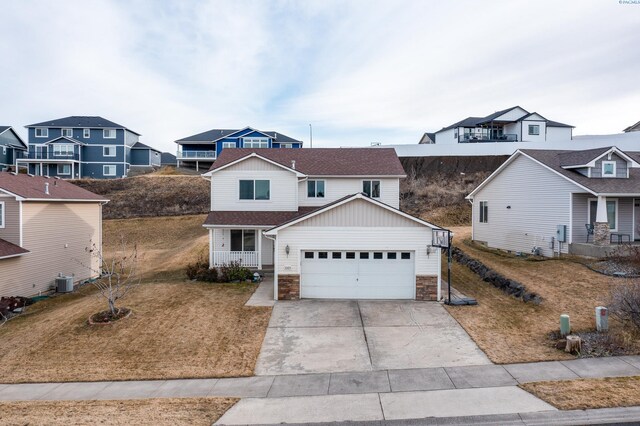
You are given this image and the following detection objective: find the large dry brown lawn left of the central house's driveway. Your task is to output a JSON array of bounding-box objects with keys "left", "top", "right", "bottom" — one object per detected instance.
[{"left": 0, "top": 216, "right": 271, "bottom": 383}]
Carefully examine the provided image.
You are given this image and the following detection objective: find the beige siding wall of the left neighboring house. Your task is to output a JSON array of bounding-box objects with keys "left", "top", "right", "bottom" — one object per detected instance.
[{"left": 0, "top": 202, "right": 102, "bottom": 296}]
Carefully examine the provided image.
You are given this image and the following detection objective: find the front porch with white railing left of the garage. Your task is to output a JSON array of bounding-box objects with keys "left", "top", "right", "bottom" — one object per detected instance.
[{"left": 209, "top": 227, "right": 273, "bottom": 269}]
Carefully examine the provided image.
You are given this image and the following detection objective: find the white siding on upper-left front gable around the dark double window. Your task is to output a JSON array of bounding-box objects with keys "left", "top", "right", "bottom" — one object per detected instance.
[{"left": 211, "top": 158, "right": 298, "bottom": 211}]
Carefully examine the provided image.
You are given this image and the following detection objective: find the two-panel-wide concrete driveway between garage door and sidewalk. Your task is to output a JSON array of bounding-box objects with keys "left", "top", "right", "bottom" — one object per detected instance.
[{"left": 256, "top": 300, "right": 491, "bottom": 375}]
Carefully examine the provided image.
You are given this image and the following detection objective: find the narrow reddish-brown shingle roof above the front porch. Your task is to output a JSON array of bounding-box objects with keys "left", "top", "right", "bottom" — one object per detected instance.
[{"left": 204, "top": 206, "right": 324, "bottom": 226}]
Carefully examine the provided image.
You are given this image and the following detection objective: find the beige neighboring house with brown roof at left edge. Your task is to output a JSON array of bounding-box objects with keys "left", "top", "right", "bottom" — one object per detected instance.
[{"left": 0, "top": 172, "right": 107, "bottom": 296}]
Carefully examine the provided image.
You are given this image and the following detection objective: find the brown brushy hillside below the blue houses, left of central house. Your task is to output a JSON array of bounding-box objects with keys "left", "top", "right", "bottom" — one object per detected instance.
[{"left": 73, "top": 175, "right": 210, "bottom": 219}]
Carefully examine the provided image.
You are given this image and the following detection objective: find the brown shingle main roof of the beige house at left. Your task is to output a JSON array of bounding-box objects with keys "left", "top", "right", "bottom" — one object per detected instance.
[{"left": 0, "top": 172, "right": 108, "bottom": 201}]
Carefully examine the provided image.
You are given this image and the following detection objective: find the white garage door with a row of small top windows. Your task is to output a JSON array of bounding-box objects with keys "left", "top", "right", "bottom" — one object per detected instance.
[{"left": 300, "top": 251, "right": 415, "bottom": 299}]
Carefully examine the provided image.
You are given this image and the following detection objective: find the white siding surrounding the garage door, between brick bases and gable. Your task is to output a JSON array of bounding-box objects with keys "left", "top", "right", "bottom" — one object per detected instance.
[{"left": 277, "top": 226, "right": 440, "bottom": 276}]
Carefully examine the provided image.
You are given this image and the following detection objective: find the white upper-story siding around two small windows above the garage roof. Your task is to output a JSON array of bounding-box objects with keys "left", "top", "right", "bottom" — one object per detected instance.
[{"left": 298, "top": 177, "right": 400, "bottom": 208}]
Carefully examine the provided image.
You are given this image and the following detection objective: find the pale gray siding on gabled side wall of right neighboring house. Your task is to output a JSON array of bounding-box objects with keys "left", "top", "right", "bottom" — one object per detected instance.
[{"left": 472, "top": 155, "right": 583, "bottom": 256}]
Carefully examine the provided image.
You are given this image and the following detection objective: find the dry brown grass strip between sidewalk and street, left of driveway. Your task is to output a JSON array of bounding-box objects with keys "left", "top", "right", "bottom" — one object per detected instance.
[{"left": 0, "top": 398, "right": 237, "bottom": 426}]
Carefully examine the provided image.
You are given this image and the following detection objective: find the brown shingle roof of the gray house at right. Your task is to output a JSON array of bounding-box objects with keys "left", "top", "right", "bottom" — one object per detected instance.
[{"left": 520, "top": 147, "right": 640, "bottom": 194}]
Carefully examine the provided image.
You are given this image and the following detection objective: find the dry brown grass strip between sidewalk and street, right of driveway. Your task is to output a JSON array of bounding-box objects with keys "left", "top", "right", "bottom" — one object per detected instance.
[{"left": 520, "top": 377, "right": 640, "bottom": 410}]
